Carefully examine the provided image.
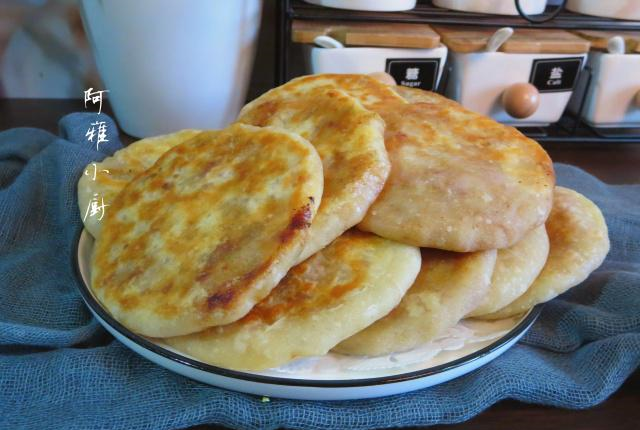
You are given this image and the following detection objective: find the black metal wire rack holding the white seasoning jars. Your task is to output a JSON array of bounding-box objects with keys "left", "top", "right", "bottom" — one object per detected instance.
[{"left": 276, "top": 0, "right": 640, "bottom": 143}]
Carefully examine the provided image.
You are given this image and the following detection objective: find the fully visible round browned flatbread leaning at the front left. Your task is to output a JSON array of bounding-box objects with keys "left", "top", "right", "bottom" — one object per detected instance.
[{"left": 91, "top": 124, "right": 322, "bottom": 337}]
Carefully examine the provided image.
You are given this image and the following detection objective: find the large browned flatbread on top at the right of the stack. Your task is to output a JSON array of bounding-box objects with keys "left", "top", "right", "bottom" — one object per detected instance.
[{"left": 358, "top": 87, "right": 555, "bottom": 252}]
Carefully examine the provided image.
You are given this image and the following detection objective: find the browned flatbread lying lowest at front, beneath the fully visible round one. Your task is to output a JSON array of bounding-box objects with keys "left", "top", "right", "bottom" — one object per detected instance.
[{"left": 164, "top": 230, "right": 420, "bottom": 370}]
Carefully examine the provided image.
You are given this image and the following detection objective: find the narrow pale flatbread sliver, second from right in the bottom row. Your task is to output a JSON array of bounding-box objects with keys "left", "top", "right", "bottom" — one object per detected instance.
[{"left": 467, "top": 225, "right": 549, "bottom": 317}]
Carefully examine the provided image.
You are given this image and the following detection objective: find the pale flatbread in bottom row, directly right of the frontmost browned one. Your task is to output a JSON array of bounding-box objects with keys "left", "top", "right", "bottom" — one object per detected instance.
[{"left": 334, "top": 245, "right": 496, "bottom": 356}]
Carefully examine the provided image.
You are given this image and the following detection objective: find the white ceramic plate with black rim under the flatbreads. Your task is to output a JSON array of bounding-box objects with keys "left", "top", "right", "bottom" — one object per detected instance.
[{"left": 74, "top": 230, "right": 540, "bottom": 400}]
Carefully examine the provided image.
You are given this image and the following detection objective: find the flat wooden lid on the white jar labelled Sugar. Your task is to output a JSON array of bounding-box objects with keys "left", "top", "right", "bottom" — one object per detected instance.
[{"left": 291, "top": 20, "right": 440, "bottom": 49}]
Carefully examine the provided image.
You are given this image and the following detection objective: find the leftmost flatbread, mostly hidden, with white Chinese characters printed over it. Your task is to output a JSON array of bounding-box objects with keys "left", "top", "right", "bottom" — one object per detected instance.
[{"left": 78, "top": 130, "right": 200, "bottom": 238}]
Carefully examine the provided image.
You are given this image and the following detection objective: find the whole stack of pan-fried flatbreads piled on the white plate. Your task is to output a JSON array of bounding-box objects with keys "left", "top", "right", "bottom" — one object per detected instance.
[{"left": 78, "top": 75, "right": 609, "bottom": 370}]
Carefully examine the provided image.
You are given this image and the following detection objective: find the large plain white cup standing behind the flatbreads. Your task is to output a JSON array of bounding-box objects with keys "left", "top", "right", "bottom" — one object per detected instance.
[{"left": 81, "top": 0, "right": 262, "bottom": 137}]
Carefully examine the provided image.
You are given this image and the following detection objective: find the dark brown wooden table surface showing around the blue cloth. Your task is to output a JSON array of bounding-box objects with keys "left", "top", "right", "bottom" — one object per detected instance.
[{"left": 0, "top": 99, "right": 640, "bottom": 430}]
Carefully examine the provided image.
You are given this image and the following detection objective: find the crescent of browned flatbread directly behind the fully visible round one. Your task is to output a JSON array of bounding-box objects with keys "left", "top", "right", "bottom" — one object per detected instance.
[{"left": 238, "top": 78, "right": 389, "bottom": 261}]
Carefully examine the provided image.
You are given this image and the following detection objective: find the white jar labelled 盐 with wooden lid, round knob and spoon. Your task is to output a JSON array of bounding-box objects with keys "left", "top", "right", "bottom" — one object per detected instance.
[{"left": 434, "top": 26, "right": 590, "bottom": 126}]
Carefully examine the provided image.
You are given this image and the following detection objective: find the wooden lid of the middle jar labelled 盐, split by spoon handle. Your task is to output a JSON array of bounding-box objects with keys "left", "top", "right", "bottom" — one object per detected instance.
[{"left": 434, "top": 26, "right": 589, "bottom": 54}]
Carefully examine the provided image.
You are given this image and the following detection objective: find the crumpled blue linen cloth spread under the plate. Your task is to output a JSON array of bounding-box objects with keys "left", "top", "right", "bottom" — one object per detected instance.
[{"left": 0, "top": 113, "right": 640, "bottom": 429}]
